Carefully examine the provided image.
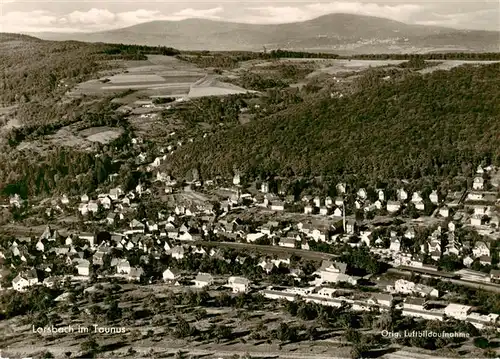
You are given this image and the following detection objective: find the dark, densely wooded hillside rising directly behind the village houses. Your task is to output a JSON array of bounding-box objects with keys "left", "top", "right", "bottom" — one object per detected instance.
[{"left": 169, "top": 64, "right": 500, "bottom": 183}]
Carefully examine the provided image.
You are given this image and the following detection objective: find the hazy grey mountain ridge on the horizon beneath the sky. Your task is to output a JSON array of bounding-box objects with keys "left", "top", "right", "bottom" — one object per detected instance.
[{"left": 34, "top": 14, "right": 500, "bottom": 53}]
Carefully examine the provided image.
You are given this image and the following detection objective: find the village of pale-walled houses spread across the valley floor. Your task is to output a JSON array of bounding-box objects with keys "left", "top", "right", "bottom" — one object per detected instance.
[{"left": 0, "top": 133, "right": 500, "bottom": 352}]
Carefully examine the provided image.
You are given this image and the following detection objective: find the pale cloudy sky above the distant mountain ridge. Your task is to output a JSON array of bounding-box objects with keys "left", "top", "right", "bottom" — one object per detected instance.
[{"left": 0, "top": 0, "right": 500, "bottom": 33}]
